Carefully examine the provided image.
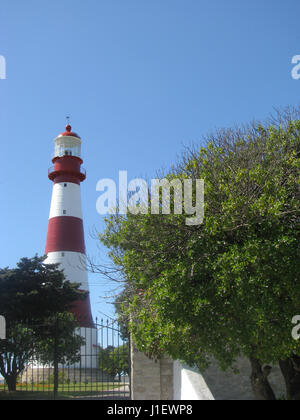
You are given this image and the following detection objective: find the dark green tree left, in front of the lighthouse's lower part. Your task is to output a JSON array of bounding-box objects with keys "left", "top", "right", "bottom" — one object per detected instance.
[{"left": 0, "top": 256, "right": 86, "bottom": 391}]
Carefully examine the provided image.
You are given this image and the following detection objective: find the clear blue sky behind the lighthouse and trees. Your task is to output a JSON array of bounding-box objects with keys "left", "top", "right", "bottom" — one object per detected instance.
[{"left": 0, "top": 0, "right": 300, "bottom": 316}]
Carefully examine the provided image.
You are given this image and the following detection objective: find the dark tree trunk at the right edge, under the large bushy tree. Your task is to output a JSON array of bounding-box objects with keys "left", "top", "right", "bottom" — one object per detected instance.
[{"left": 279, "top": 356, "right": 300, "bottom": 401}]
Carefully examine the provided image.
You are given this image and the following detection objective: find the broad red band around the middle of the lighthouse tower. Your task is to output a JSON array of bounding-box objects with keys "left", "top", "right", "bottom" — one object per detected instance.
[{"left": 45, "top": 216, "right": 85, "bottom": 254}]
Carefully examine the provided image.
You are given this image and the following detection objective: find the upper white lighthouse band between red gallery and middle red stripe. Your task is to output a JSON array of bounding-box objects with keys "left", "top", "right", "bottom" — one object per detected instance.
[{"left": 49, "top": 182, "right": 82, "bottom": 219}]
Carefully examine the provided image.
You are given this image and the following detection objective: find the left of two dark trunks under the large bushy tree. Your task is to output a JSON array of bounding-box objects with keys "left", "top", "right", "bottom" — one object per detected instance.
[{"left": 250, "top": 358, "right": 276, "bottom": 401}]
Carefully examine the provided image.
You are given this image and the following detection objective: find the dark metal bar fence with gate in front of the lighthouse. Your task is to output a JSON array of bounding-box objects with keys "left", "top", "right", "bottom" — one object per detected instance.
[{"left": 0, "top": 319, "right": 130, "bottom": 400}]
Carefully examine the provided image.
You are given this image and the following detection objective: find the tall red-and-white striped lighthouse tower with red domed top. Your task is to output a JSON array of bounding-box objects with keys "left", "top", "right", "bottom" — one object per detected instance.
[{"left": 45, "top": 124, "right": 97, "bottom": 368}]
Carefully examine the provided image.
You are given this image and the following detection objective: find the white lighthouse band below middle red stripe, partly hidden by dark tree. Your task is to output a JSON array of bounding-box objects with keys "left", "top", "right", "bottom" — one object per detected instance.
[{"left": 45, "top": 251, "right": 89, "bottom": 291}]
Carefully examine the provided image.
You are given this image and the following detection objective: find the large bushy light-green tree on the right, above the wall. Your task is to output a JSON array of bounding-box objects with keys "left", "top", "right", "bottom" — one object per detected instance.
[{"left": 100, "top": 108, "right": 300, "bottom": 399}]
